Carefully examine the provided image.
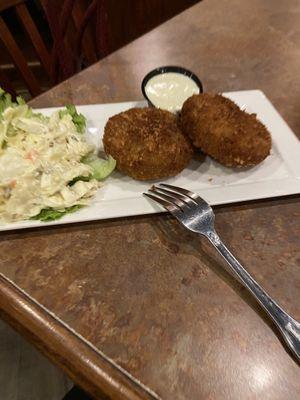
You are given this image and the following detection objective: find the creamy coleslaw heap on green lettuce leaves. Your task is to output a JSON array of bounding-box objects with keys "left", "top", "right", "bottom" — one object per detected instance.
[{"left": 0, "top": 88, "right": 116, "bottom": 223}]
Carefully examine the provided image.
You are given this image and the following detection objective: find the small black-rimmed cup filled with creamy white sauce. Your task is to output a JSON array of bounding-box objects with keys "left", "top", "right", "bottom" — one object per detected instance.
[{"left": 142, "top": 66, "right": 203, "bottom": 113}]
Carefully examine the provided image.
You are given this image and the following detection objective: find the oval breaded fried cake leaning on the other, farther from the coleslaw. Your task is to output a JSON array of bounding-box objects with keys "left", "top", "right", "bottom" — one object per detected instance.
[{"left": 181, "top": 93, "right": 271, "bottom": 167}]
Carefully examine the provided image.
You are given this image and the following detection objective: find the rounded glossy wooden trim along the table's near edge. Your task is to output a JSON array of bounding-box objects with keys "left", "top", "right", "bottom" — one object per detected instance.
[{"left": 0, "top": 274, "right": 159, "bottom": 400}]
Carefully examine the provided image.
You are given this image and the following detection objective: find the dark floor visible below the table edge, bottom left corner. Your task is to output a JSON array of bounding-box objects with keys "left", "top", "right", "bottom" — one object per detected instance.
[{"left": 0, "top": 321, "right": 72, "bottom": 400}]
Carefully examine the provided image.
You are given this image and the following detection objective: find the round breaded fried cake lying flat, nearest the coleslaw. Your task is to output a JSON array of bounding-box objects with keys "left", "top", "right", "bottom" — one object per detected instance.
[{"left": 103, "top": 108, "right": 193, "bottom": 180}]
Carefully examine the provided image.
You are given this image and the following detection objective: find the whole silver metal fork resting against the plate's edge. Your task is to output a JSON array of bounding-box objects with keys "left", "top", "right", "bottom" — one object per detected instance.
[{"left": 144, "top": 183, "right": 300, "bottom": 361}]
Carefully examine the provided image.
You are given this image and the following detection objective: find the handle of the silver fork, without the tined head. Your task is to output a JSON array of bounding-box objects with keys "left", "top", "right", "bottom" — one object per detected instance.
[{"left": 206, "top": 231, "right": 300, "bottom": 360}]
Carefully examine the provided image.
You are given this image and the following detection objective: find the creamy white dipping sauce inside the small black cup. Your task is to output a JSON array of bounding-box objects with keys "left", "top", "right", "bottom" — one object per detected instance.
[{"left": 145, "top": 72, "right": 199, "bottom": 112}]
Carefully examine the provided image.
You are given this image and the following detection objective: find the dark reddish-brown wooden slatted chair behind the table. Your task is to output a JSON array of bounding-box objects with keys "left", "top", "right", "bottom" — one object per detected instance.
[{"left": 0, "top": 0, "right": 108, "bottom": 96}]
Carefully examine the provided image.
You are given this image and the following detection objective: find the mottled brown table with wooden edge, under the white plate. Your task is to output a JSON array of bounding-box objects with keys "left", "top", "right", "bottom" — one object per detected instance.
[{"left": 0, "top": 0, "right": 300, "bottom": 400}]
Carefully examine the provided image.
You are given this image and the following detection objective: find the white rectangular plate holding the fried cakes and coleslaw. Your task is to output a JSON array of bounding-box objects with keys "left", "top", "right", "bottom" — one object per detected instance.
[{"left": 0, "top": 90, "right": 300, "bottom": 231}]
